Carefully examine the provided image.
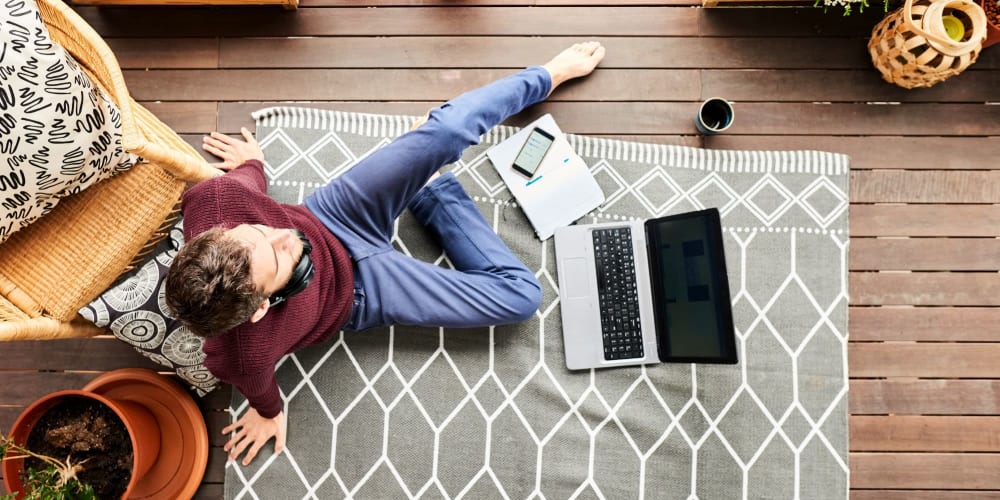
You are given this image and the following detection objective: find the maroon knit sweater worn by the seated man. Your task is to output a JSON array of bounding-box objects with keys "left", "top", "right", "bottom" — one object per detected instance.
[{"left": 181, "top": 160, "right": 354, "bottom": 418}]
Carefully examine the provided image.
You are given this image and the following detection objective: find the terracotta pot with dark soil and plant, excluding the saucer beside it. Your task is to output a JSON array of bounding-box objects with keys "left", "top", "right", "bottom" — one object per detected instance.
[{"left": 2, "top": 390, "right": 160, "bottom": 499}]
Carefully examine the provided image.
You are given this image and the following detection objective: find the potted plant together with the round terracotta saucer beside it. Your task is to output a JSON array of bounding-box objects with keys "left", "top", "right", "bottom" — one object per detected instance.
[{"left": 0, "top": 368, "right": 208, "bottom": 500}]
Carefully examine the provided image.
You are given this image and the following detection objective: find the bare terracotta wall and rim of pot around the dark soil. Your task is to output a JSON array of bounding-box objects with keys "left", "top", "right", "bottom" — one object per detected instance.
[{"left": 3, "top": 390, "right": 160, "bottom": 498}]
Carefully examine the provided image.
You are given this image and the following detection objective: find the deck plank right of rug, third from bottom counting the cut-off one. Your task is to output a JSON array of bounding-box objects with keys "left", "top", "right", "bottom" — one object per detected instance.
[{"left": 850, "top": 415, "right": 1000, "bottom": 452}]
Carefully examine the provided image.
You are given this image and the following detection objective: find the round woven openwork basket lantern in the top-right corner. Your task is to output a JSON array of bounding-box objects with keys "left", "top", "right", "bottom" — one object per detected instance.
[{"left": 868, "top": 0, "right": 986, "bottom": 89}]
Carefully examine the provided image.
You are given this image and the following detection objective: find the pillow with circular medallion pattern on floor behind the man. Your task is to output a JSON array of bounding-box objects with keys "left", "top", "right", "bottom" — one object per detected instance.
[{"left": 80, "top": 222, "right": 219, "bottom": 396}]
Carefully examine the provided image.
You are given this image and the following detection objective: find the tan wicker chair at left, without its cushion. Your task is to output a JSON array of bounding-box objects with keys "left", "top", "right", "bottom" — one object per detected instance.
[{"left": 0, "top": 0, "right": 219, "bottom": 340}]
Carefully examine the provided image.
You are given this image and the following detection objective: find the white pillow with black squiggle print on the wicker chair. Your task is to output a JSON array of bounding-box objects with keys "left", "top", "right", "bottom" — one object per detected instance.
[{"left": 0, "top": 0, "right": 138, "bottom": 242}]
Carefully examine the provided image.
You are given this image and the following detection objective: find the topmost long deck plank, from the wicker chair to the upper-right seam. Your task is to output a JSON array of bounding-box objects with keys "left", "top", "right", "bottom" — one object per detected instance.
[{"left": 78, "top": 6, "right": 700, "bottom": 38}]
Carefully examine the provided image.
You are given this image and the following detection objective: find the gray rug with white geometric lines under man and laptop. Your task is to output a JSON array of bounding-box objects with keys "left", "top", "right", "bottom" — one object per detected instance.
[{"left": 225, "top": 108, "right": 849, "bottom": 500}]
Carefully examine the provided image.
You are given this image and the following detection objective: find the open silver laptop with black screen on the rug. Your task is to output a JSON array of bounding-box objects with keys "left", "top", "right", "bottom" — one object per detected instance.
[{"left": 555, "top": 208, "right": 737, "bottom": 370}]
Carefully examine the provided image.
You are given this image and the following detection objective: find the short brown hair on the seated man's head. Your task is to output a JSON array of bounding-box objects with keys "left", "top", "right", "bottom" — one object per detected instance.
[{"left": 165, "top": 228, "right": 267, "bottom": 337}]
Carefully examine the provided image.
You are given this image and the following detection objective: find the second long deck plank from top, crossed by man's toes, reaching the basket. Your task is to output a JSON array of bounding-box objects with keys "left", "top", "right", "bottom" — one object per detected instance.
[{"left": 217, "top": 36, "right": 876, "bottom": 70}]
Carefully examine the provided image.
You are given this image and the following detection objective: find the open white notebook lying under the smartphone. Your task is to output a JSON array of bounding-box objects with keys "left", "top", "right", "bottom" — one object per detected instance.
[{"left": 486, "top": 114, "right": 604, "bottom": 240}]
